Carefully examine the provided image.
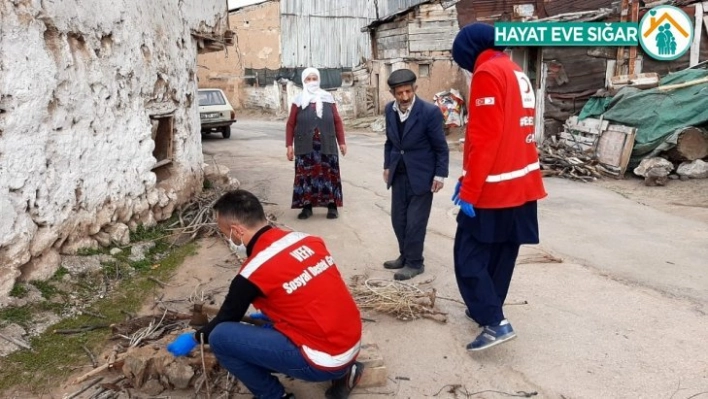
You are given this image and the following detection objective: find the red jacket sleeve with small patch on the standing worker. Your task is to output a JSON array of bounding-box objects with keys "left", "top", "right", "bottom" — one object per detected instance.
[{"left": 460, "top": 71, "right": 505, "bottom": 205}]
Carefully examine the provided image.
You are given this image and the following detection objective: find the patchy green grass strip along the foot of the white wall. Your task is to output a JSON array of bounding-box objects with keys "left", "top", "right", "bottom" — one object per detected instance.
[{"left": 0, "top": 236, "right": 196, "bottom": 397}]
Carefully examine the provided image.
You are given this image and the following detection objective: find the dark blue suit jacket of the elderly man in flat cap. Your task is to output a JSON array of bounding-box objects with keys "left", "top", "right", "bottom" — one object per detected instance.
[{"left": 384, "top": 97, "right": 450, "bottom": 195}]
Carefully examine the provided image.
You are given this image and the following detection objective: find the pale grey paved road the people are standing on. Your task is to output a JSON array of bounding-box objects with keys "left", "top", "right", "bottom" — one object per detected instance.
[{"left": 203, "top": 120, "right": 708, "bottom": 399}]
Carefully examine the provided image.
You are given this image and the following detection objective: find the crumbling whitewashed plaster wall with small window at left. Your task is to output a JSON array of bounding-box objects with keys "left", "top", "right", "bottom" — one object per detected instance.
[{"left": 0, "top": 0, "right": 226, "bottom": 307}]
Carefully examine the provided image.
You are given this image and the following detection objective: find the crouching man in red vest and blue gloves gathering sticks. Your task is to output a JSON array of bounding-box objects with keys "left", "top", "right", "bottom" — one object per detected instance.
[{"left": 167, "top": 190, "right": 362, "bottom": 399}]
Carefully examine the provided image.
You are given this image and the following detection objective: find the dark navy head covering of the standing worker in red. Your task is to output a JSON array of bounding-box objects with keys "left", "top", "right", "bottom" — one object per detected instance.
[{"left": 452, "top": 22, "right": 506, "bottom": 72}]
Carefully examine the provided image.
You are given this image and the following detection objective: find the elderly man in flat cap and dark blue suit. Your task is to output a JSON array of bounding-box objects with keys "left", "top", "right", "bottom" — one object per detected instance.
[{"left": 383, "top": 69, "right": 450, "bottom": 280}]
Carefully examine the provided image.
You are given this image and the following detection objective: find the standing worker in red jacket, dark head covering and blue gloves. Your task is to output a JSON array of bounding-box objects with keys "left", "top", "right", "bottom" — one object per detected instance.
[{"left": 452, "top": 23, "right": 546, "bottom": 351}]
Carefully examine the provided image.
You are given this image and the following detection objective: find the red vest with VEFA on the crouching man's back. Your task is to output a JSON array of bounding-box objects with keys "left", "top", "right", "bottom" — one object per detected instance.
[{"left": 239, "top": 228, "right": 362, "bottom": 370}]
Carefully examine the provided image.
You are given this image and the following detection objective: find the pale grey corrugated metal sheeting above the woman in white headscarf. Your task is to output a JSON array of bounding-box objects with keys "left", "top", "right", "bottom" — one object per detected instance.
[{"left": 280, "top": 0, "right": 375, "bottom": 68}]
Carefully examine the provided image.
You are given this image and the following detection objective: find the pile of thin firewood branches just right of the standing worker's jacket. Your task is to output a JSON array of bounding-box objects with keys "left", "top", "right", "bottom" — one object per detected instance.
[{"left": 538, "top": 137, "right": 604, "bottom": 182}]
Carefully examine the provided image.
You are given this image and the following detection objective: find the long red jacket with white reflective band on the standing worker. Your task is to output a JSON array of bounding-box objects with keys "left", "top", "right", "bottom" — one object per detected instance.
[{"left": 460, "top": 50, "right": 546, "bottom": 209}]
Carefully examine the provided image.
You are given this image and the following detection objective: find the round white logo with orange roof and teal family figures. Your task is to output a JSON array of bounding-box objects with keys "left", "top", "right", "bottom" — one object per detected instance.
[{"left": 639, "top": 6, "right": 693, "bottom": 61}]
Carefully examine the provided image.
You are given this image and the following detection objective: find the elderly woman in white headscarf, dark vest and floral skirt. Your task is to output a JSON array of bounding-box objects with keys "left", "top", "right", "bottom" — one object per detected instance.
[{"left": 285, "top": 68, "right": 347, "bottom": 219}]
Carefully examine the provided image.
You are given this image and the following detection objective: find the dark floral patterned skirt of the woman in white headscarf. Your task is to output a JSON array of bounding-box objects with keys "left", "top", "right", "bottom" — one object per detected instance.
[{"left": 292, "top": 134, "right": 342, "bottom": 209}]
